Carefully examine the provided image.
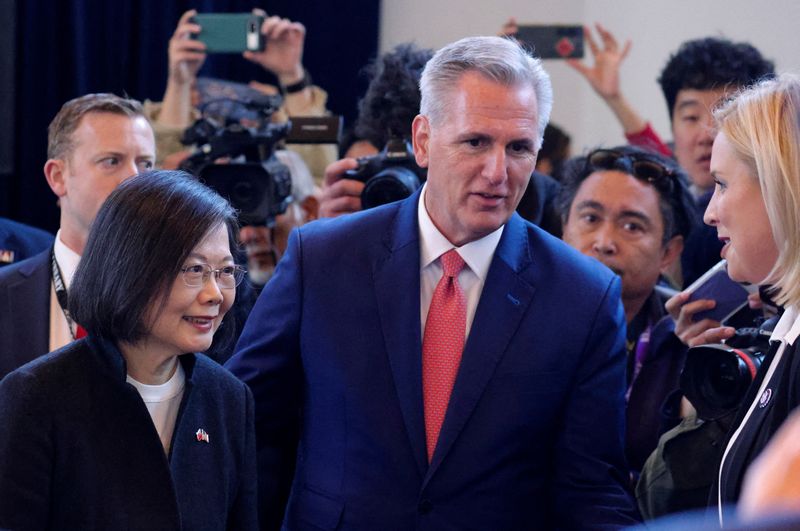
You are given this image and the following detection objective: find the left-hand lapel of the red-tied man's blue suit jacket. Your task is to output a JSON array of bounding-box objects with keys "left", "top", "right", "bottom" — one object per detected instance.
[{"left": 373, "top": 191, "right": 428, "bottom": 476}]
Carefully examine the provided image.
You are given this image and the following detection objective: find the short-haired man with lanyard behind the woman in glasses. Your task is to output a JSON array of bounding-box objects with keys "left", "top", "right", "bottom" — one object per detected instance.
[{"left": 0, "top": 94, "right": 156, "bottom": 378}]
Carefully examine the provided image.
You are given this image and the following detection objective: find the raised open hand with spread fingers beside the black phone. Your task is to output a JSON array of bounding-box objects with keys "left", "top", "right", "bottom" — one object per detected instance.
[{"left": 567, "top": 24, "right": 631, "bottom": 101}]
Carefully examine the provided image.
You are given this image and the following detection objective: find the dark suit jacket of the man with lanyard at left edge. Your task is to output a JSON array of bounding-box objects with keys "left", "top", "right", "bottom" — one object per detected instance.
[{"left": 0, "top": 249, "right": 50, "bottom": 379}]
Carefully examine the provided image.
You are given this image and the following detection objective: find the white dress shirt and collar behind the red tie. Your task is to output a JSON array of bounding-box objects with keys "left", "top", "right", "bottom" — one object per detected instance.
[{"left": 417, "top": 184, "right": 505, "bottom": 338}]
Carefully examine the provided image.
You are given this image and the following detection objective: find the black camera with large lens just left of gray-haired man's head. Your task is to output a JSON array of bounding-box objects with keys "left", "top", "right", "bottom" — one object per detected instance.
[{"left": 344, "top": 137, "right": 428, "bottom": 210}]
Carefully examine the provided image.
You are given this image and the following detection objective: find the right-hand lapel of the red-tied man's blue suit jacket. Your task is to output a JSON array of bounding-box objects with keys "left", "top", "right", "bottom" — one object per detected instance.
[{"left": 425, "top": 214, "right": 534, "bottom": 482}]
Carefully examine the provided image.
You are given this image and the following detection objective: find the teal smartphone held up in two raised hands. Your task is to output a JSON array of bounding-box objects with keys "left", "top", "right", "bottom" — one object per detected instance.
[{"left": 193, "top": 13, "right": 266, "bottom": 53}]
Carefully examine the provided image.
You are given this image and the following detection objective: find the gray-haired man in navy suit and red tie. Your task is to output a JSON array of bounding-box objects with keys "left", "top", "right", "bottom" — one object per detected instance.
[{"left": 227, "top": 37, "right": 636, "bottom": 530}]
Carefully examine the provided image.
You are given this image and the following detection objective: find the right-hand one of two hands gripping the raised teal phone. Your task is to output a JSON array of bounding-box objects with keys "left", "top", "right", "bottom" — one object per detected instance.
[{"left": 244, "top": 9, "right": 306, "bottom": 86}]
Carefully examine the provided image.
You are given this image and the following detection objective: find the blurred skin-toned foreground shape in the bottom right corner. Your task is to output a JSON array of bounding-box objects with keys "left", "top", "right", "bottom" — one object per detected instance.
[{"left": 739, "top": 410, "right": 800, "bottom": 519}]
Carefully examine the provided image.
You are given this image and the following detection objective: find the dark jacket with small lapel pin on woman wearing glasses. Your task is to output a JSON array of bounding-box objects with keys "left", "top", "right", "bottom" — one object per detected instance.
[{"left": 0, "top": 338, "right": 257, "bottom": 530}]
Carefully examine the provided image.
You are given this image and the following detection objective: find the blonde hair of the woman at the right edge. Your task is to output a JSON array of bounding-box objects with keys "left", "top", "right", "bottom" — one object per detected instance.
[{"left": 714, "top": 74, "right": 800, "bottom": 306}]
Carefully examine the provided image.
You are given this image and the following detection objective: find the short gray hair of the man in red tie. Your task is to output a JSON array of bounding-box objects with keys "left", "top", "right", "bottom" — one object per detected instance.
[{"left": 419, "top": 37, "right": 553, "bottom": 149}]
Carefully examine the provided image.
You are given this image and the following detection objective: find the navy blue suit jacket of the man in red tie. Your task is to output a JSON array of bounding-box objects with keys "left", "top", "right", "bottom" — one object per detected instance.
[{"left": 226, "top": 189, "right": 636, "bottom": 530}]
